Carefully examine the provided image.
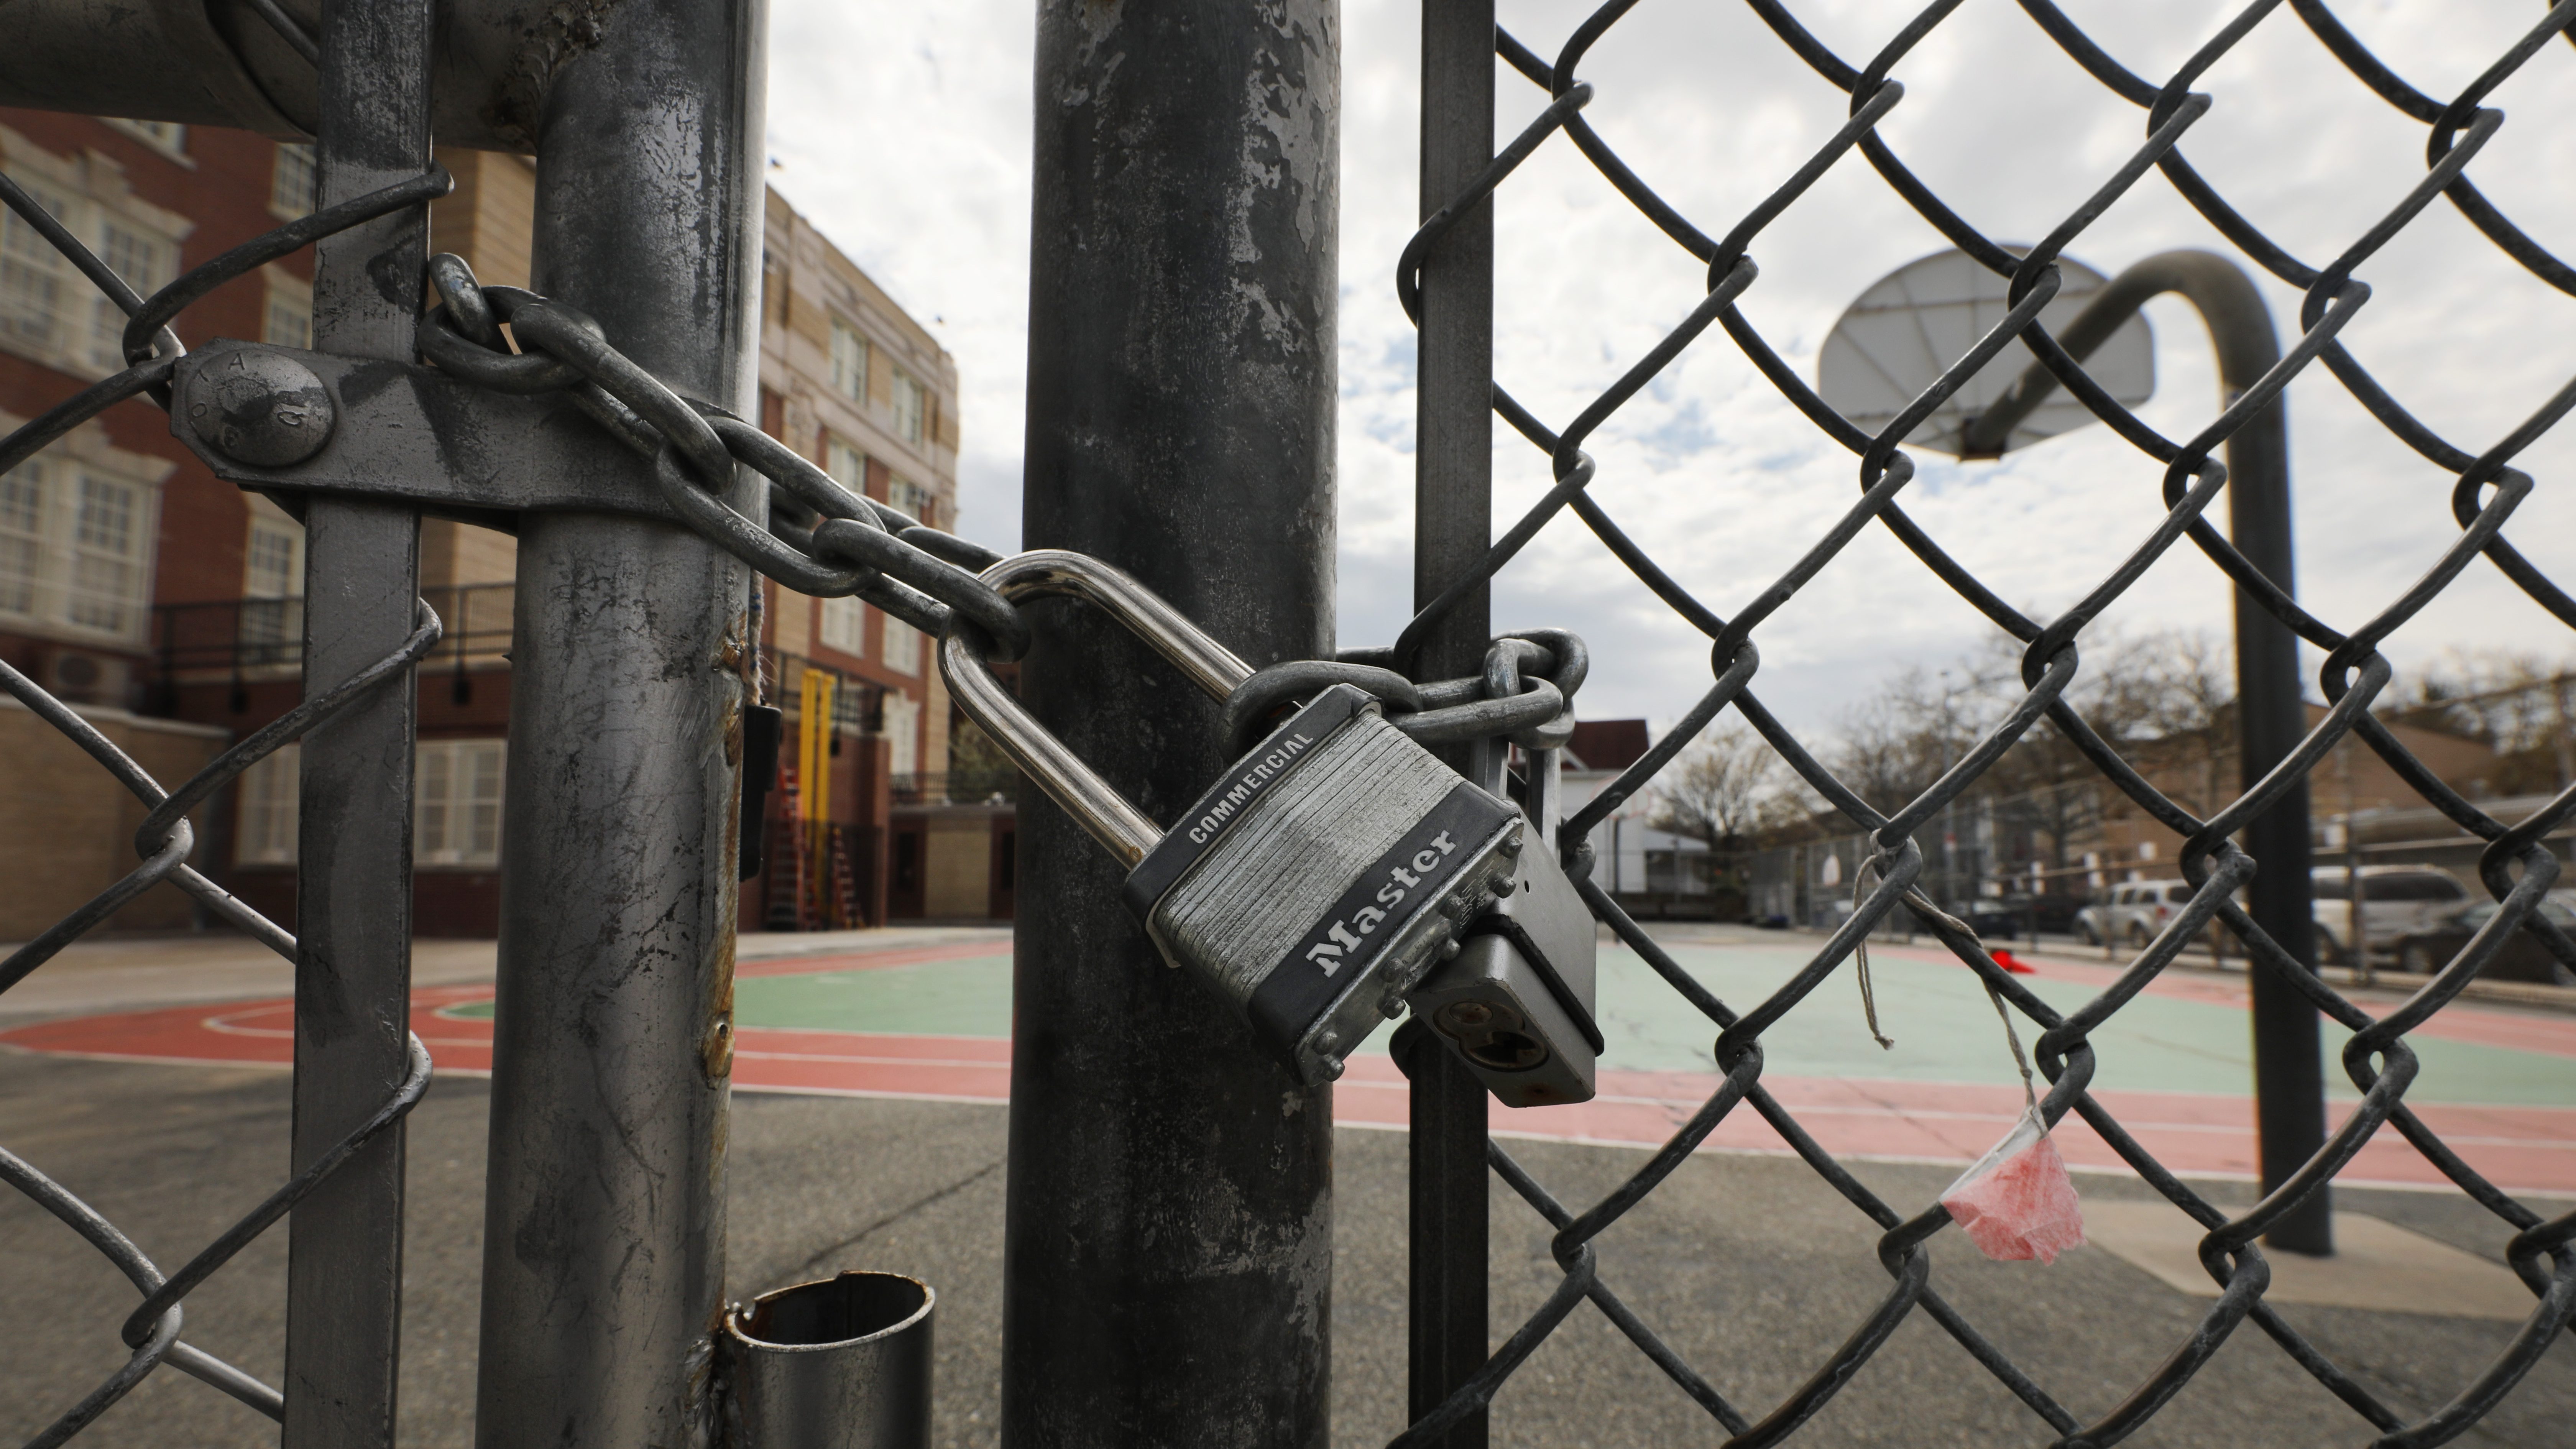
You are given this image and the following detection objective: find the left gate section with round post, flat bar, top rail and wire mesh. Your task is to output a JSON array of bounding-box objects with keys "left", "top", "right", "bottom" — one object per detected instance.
[{"left": 0, "top": 0, "right": 767, "bottom": 1449}]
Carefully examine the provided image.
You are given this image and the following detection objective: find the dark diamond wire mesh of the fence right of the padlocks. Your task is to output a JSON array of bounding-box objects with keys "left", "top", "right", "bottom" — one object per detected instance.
[{"left": 1394, "top": 0, "right": 2576, "bottom": 1446}]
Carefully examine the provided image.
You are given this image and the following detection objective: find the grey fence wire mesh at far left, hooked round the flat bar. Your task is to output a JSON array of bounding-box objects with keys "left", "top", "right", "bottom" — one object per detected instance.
[{"left": 0, "top": 168, "right": 453, "bottom": 1449}]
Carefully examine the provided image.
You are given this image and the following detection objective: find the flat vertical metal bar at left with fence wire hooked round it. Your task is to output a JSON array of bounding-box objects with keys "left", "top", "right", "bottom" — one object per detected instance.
[{"left": 281, "top": 0, "right": 430, "bottom": 1449}]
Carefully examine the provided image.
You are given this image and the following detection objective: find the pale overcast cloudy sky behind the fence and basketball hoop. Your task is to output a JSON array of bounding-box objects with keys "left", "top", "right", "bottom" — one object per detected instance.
[{"left": 770, "top": 0, "right": 2576, "bottom": 729}]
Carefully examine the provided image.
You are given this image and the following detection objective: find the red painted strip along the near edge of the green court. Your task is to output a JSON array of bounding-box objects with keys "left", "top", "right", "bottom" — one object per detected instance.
[{"left": 0, "top": 987, "right": 2576, "bottom": 1194}]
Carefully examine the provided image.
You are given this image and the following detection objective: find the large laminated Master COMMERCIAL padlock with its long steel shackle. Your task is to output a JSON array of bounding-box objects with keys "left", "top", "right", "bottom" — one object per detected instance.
[{"left": 940, "top": 549, "right": 1523, "bottom": 1083}]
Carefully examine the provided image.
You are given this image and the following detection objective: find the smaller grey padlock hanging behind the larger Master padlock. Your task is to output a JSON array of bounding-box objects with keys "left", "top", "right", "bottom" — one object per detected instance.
[{"left": 1409, "top": 815, "right": 1605, "bottom": 1106}]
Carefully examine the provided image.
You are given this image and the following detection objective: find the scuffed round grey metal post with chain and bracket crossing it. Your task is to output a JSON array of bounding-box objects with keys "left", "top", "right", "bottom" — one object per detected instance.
[{"left": 476, "top": 0, "right": 768, "bottom": 1449}]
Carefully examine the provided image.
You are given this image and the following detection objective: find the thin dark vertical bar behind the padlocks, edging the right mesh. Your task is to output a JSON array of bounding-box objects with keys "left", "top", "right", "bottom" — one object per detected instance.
[{"left": 1399, "top": 0, "right": 1494, "bottom": 1449}]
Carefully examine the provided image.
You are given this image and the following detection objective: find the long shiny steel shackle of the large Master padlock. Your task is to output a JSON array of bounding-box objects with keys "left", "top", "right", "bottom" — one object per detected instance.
[{"left": 940, "top": 549, "right": 1252, "bottom": 869}]
